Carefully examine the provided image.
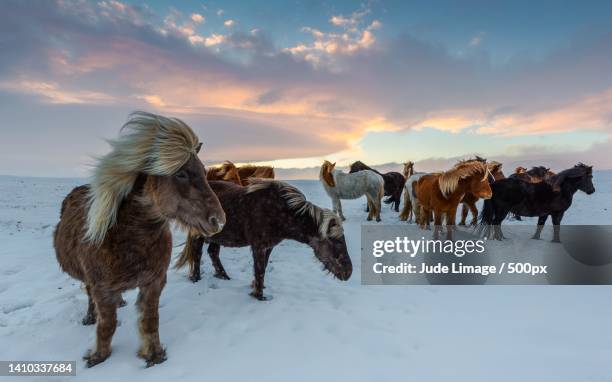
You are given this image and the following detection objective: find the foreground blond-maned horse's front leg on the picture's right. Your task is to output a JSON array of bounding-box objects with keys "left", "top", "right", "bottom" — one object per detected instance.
[{"left": 136, "top": 275, "right": 166, "bottom": 367}]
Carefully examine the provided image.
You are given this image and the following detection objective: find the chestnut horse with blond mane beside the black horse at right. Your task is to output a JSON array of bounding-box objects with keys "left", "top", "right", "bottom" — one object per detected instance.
[{"left": 415, "top": 160, "right": 491, "bottom": 240}]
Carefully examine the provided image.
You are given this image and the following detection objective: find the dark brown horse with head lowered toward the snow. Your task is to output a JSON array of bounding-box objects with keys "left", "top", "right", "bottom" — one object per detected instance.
[{"left": 176, "top": 179, "right": 353, "bottom": 300}]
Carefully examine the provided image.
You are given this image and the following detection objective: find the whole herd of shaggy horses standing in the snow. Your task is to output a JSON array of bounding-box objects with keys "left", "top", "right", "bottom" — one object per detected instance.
[{"left": 53, "top": 112, "right": 594, "bottom": 367}]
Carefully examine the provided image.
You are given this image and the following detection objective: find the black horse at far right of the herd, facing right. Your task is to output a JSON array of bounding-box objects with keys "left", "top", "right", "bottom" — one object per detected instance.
[{"left": 480, "top": 163, "right": 595, "bottom": 242}]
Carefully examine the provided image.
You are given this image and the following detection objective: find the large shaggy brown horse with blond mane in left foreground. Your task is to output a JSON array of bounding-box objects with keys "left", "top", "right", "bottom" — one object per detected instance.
[{"left": 53, "top": 112, "right": 225, "bottom": 367}]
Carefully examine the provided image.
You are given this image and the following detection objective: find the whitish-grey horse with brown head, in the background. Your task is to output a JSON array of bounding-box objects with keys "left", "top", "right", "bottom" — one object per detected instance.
[{"left": 319, "top": 161, "right": 385, "bottom": 222}]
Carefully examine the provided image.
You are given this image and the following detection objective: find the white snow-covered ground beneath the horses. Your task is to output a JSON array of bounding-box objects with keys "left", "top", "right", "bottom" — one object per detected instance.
[{"left": 0, "top": 172, "right": 612, "bottom": 382}]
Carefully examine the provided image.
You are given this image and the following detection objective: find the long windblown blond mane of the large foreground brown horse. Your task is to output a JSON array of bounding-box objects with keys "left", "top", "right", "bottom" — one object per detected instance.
[{"left": 85, "top": 111, "right": 201, "bottom": 244}]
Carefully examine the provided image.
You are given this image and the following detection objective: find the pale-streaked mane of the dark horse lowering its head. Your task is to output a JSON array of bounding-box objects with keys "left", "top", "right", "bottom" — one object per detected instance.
[{"left": 246, "top": 178, "right": 344, "bottom": 238}]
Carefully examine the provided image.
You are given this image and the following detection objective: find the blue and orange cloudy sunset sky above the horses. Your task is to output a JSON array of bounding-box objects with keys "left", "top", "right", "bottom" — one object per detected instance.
[{"left": 0, "top": 0, "right": 612, "bottom": 176}]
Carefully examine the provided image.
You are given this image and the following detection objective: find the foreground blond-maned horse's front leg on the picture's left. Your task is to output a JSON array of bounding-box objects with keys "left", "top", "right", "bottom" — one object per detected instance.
[{"left": 83, "top": 287, "right": 121, "bottom": 367}]
